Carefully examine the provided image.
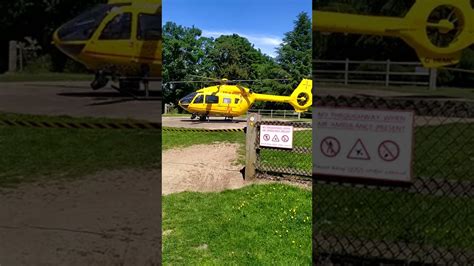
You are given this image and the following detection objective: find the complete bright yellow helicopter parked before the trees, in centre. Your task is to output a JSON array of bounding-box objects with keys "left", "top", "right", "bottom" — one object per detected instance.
[{"left": 179, "top": 79, "right": 313, "bottom": 121}]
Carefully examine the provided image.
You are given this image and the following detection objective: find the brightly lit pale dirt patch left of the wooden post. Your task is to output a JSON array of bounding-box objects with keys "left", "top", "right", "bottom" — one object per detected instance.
[{"left": 162, "top": 143, "right": 256, "bottom": 195}]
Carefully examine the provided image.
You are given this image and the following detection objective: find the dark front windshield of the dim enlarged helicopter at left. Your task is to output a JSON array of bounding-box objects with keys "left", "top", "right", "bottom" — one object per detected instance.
[{"left": 58, "top": 4, "right": 117, "bottom": 41}]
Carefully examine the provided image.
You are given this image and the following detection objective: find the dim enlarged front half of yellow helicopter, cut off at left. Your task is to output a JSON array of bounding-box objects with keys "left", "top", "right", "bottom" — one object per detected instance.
[{"left": 53, "top": 0, "right": 162, "bottom": 90}]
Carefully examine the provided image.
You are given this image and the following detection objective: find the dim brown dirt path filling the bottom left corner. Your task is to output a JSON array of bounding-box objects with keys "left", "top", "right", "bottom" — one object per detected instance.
[{"left": 0, "top": 169, "right": 161, "bottom": 265}]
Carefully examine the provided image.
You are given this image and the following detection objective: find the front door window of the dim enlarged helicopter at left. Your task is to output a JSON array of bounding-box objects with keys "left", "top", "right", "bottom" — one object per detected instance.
[{"left": 99, "top": 13, "right": 132, "bottom": 40}]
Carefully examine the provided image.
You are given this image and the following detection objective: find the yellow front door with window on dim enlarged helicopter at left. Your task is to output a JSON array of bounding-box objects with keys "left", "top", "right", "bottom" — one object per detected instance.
[{"left": 86, "top": 10, "right": 135, "bottom": 68}]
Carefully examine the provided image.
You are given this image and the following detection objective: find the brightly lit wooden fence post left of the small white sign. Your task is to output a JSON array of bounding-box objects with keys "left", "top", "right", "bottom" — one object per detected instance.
[{"left": 245, "top": 114, "right": 261, "bottom": 180}]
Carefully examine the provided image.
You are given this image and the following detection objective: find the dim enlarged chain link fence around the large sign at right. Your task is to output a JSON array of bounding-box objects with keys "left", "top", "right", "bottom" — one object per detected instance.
[{"left": 313, "top": 96, "right": 474, "bottom": 265}]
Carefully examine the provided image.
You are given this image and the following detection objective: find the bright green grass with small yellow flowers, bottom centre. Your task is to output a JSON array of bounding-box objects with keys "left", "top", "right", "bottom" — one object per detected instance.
[{"left": 163, "top": 184, "right": 311, "bottom": 265}]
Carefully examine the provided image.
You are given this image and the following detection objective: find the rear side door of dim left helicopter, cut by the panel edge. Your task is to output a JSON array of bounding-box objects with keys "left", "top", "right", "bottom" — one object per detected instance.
[{"left": 136, "top": 12, "right": 162, "bottom": 75}]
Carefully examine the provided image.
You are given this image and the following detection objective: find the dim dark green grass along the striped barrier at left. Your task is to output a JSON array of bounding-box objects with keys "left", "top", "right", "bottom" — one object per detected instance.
[{"left": 0, "top": 114, "right": 161, "bottom": 187}]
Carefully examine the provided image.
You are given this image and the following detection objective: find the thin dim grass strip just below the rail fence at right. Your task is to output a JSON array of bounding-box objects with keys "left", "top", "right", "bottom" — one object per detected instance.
[{"left": 318, "top": 83, "right": 474, "bottom": 100}]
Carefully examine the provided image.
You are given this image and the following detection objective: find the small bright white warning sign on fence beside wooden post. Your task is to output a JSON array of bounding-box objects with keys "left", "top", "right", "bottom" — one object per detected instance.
[{"left": 260, "top": 125, "right": 293, "bottom": 149}]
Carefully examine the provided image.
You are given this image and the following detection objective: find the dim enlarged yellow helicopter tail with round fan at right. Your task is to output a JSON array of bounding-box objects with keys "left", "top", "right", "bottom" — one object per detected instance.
[{"left": 313, "top": 0, "right": 474, "bottom": 68}]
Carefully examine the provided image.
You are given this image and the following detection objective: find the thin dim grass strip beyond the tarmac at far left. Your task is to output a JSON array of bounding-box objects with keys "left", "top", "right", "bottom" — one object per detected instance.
[{"left": 0, "top": 72, "right": 94, "bottom": 82}]
